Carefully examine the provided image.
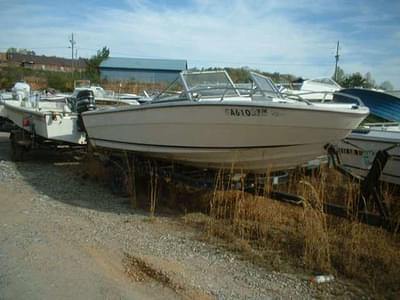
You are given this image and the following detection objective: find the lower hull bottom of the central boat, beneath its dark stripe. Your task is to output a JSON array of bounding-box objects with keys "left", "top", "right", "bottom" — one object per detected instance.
[{"left": 90, "top": 139, "right": 332, "bottom": 173}]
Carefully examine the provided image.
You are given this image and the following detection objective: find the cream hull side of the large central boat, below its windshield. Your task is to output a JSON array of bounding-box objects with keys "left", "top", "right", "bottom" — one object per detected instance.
[{"left": 82, "top": 103, "right": 366, "bottom": 172}]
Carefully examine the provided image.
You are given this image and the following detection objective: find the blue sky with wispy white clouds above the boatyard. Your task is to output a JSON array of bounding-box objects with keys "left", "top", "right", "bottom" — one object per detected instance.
[{"left": 0, "top": 0, "right": 400, "bottom": 89}]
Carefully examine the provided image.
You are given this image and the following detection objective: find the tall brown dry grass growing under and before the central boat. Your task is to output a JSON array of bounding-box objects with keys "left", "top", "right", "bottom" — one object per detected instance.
[{"left": 83, "top": 156, "right": 400, "bottom": 299}]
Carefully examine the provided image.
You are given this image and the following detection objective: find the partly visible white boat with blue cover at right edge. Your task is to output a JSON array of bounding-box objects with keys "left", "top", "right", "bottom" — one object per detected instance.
[{"left": 332, "top": 88, "right": 400, "bottom": 185}]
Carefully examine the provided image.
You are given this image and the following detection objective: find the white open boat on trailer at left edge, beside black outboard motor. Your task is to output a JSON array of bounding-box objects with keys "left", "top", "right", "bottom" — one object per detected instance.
[{"left": 1, "top": 82, "right": 100, "bottom": 160}]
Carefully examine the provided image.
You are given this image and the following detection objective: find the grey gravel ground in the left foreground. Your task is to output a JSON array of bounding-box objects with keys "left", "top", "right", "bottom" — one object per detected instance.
[{"left": 0, "top": 133, "right": 368, "bottom": 299}]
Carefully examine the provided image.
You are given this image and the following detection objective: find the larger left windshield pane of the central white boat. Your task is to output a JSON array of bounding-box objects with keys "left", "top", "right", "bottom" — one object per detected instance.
[{"left": 182, "top": 71, "right": 239, "bottom": 98}]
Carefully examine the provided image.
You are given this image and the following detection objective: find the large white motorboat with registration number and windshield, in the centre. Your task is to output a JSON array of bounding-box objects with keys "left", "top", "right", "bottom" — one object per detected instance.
[{"left": 82, "top": 71, "right": 369, "bottom": 172}]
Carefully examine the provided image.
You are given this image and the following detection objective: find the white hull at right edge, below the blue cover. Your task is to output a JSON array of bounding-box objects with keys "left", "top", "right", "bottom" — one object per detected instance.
[{"left": 338, "top": 123, "right": 400, "bottom": 185}]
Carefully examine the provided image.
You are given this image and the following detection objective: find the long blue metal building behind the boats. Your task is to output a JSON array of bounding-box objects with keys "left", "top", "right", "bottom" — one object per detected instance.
[{"left": 100, "top": 57, "right": 187, "bottom": 83}]
